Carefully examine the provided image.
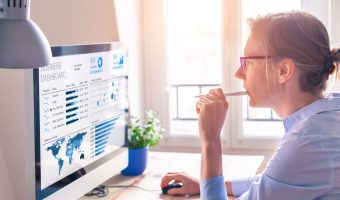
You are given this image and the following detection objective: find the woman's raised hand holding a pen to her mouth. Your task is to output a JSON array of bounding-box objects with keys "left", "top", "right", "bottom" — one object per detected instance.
[{"left": 196, "top": 88, "right": 228, "bottom": 144}]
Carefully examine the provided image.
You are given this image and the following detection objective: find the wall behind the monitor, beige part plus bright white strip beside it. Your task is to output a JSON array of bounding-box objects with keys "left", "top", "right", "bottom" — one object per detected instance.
[{"left": 31, "top": 0, "right": 144, "bottom": 116}]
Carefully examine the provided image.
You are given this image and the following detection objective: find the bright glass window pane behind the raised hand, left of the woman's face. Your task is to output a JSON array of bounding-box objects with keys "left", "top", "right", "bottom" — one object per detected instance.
[{"left": 166, "top": 0, "right": 222, "bottom": 136}]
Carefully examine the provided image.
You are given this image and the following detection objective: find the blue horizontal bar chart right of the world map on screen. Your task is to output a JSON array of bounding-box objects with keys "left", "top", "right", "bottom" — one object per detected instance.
[{"left": 94, "top": 117, "right": 119, "bottom": 156}]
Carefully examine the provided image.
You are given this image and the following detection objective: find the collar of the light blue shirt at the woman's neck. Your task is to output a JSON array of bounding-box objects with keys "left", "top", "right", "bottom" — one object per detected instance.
[{"left": 283, "top": 93, "right": 340, "bottom": 133}]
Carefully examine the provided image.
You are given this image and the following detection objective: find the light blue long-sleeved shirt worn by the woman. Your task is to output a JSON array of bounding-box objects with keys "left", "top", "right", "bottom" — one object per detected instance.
[{"left": 200, "top": 93, "right": 340, "bottom": 200}]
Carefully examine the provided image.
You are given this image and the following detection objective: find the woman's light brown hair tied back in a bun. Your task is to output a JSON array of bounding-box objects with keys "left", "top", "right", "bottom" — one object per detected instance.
[{"left": 248, "top": 11, "right": 340, "bottom": 93}]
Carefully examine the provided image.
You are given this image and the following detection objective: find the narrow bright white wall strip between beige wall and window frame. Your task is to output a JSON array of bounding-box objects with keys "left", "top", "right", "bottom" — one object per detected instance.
[{"left": 114, "top": 0, "right": 145, "bottom": 116}]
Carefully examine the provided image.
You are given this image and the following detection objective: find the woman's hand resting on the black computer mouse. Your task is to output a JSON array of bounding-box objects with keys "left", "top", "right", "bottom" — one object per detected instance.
[{"left": 161, "top": 172, "right": 200, "bottom": 195}]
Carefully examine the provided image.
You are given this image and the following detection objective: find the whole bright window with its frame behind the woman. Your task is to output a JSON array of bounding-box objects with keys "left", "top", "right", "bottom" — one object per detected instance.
[{"left": 143, "top": 0, "right": 310, "bottom": 149}]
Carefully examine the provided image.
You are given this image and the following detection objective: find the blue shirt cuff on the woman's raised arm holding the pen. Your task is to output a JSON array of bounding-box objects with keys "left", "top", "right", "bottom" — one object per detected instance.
[{"left": 200, "top": 176, "right": 228, "bottom": 200}]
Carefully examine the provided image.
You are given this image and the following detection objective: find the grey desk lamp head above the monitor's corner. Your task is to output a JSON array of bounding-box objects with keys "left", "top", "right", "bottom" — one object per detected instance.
[{"left": 0, "top": 0, "right": 52, "bottom": 69}]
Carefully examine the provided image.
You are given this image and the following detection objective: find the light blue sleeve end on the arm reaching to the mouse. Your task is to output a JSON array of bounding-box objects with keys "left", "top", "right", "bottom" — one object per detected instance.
[{"left": 231, "top": 174, "right": 261, "bottom": 197}]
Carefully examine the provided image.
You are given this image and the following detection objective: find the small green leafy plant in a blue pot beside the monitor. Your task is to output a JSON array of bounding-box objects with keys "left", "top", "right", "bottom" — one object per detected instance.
[{"left": 121, "top": 110, "right": 164, "bottom": 176}]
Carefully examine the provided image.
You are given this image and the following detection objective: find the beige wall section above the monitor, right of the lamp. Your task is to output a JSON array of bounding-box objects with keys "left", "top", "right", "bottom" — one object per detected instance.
[{"left": 31, "top": 0, "right": 119, "bottom": 46}]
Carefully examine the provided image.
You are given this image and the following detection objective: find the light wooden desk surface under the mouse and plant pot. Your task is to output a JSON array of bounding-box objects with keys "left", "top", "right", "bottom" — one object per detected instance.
[{"left": 81, "top": 152, "right": 264, "bottom": 200}]
